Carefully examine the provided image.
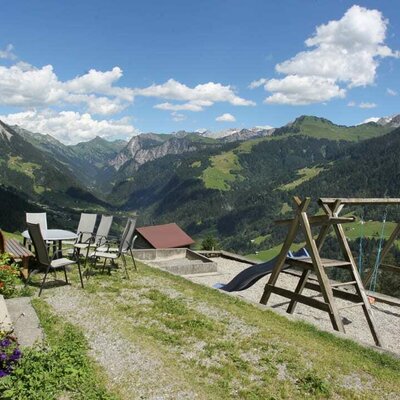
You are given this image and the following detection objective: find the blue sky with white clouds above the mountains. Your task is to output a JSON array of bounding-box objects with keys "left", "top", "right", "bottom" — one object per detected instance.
[{"left": 0, "top": 0, "right": 400, "bottom": 144}]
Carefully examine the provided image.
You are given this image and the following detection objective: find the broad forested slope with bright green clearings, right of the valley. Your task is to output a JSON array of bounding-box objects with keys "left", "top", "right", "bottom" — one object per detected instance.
[{"left": 113, "top": 123, "right": 400, "bottom": 251}]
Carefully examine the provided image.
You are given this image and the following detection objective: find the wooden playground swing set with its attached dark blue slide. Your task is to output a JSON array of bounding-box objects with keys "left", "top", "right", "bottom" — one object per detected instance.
[{"left": 219, "top": 197, "right": 400, "bottom": 346}]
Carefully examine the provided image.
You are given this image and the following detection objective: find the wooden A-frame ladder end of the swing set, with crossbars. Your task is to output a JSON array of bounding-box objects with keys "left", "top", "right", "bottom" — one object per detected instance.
[{"left": 260, "top": 197, "right": 382, "bottom": 346}]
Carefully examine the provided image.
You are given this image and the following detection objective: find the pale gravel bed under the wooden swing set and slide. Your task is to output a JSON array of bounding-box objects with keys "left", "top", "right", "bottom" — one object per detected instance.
[{"left": 185, "top": 257, "right": 400, "bottom": 355}]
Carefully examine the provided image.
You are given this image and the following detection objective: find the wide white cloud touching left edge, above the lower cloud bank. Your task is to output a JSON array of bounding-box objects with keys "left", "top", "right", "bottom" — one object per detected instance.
[{"left": 0, "top": 62, "right": 133, "bottom": 115}]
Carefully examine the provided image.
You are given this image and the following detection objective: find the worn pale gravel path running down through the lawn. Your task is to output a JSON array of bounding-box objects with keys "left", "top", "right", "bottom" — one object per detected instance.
[{"left": 45, "top": 286, "right": 197, "bottom": 400}]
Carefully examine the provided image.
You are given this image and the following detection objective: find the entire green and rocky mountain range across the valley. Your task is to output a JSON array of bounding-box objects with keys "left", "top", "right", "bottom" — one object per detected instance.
[{"left": 0, "top": 115, "right": 400, "bottom": 252}]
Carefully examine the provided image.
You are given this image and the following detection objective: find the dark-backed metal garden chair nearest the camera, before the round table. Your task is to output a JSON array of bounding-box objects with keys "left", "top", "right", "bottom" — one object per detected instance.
[{"left": 27, "top": 223, "right": 83, "bottom": 296}]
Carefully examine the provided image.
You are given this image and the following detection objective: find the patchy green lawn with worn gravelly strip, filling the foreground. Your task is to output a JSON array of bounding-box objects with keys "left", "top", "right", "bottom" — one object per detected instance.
[{"left": 0, "top": 230, "right": 400, "bottom": 400}]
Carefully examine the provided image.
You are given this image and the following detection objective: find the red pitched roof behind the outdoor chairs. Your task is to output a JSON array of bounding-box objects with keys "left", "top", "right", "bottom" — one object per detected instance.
[{"left": 136, "top": 223, "right": 194, "bottom": 249}]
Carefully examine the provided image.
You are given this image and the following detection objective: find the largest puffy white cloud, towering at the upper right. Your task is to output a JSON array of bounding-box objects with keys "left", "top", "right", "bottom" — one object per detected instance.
[{"left": 265, "top": 5, "right": 400, "bottom": 104}]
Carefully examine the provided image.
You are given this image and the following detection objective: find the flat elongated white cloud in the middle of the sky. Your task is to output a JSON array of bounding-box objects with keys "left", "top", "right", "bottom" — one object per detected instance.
[{"left": 134, "top": 79, "right": 255, "bottom": 111}]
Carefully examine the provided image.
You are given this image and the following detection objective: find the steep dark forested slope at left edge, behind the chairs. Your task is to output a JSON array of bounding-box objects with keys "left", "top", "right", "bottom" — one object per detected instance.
[{"left": 0, "top": 121, "right": 106, "bottom": 230}]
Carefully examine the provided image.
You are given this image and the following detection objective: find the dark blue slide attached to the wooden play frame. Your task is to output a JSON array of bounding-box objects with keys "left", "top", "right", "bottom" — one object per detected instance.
[{"left": 214, "top": 248, "right": 310, "bottom": 292}]
